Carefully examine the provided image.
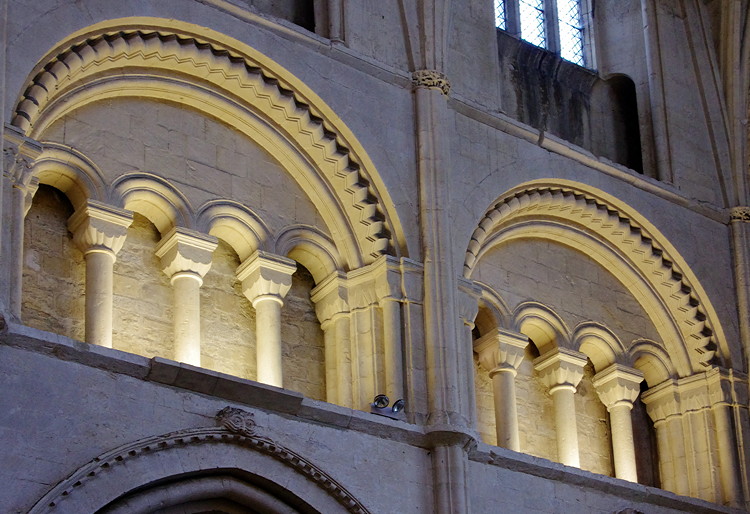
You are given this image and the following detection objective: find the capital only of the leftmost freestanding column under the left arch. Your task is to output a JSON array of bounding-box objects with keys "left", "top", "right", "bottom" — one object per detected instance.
[{"left": 68, "top": 200, "right": 133, "bottom": 257}]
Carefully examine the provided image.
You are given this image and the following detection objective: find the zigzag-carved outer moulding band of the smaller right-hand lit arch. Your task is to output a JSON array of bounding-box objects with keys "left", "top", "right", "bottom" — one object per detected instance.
[{"left": 464, "top": 183, "right": 728, "bottom": 375}]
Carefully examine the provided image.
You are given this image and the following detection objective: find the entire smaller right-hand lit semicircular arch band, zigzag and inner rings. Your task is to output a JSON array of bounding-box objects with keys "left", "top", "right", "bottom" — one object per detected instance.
[{"left": 464, "top": 180, "right": 732, "bottom": 376}]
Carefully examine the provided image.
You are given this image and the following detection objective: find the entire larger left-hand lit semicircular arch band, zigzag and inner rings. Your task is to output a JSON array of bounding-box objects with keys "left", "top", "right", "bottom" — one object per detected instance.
[{"left": 8, "top": 18, "right": 408, "bottom": 269}]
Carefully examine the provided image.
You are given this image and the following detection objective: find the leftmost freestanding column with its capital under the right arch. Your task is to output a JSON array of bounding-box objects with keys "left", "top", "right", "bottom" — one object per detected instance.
[{"left": 474, "top": 328, "right": 529, "bottom": 452}]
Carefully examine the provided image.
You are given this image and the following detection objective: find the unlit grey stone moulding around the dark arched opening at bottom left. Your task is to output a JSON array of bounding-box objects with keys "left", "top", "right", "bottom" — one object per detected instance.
[{"left": 29, "top": 407, "right": 369, "bottom": 514}]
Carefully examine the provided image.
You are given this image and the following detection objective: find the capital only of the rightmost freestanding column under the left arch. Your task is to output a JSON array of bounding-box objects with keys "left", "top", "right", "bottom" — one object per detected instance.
[{"left": 237, "top": 250, "right": 297, "bottom": 306}]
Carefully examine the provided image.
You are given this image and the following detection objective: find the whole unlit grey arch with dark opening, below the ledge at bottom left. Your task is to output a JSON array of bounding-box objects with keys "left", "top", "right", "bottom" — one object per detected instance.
[{"left": 29, "top": 407, "right": 368, "bottom": 514}]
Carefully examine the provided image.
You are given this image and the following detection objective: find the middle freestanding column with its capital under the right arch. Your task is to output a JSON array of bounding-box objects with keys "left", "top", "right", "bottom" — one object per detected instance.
[{"left": 534, "top": 348, "right": 587, "bottom": 467}]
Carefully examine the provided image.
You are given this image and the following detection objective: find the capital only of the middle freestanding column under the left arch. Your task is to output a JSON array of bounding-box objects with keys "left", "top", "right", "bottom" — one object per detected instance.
[{"left": 156, "top": 227, "right": 218, "bottom": 282}]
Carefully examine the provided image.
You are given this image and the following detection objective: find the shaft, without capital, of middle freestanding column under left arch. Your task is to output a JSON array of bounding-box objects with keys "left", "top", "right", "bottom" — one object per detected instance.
[{"left": 172, "top": 272, "right": 203, "bottom": 366}]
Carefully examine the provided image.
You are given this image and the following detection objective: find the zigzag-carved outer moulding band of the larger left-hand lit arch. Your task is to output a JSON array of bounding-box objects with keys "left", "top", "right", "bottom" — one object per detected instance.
[{"left": 12, "top": 30, "right": 400, "bottom": 268}]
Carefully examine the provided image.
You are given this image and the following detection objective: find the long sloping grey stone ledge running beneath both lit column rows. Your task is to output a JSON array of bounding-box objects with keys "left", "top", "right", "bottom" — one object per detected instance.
[{"left": 0, "top": 324, "right": 742, "bottom": 514}]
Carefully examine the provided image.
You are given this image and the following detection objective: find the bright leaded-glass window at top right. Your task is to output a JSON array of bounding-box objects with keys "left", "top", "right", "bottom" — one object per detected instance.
[{"left": 494, "top": 0, "right": 592, "bottom": 68}]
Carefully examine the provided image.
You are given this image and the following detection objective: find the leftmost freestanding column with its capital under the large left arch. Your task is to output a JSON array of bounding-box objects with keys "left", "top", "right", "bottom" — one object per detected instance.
[{"left": 68, "top": 200, "right": 133, "bottom": 348}]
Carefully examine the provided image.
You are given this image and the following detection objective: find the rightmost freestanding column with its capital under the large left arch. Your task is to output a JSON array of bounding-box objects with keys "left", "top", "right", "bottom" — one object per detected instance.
[{"left": 237, "top": 250, "right": 297, "bottom": 387}]
